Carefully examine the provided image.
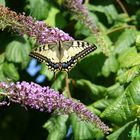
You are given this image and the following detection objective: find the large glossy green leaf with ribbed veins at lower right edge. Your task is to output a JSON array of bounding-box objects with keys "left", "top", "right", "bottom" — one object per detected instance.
[{"left": 101, "top": 77, "right": 140, "bottom": 125}]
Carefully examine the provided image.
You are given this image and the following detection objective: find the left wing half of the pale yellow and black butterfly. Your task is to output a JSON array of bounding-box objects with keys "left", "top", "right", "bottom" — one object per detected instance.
[{"left": 30, "top": 43, "right": 60, "bottom": 71}]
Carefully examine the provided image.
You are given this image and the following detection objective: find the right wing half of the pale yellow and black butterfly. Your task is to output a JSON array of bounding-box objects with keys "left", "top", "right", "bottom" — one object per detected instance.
[{"left": 61, "top": 41, "right": 97, "bottom": 71}]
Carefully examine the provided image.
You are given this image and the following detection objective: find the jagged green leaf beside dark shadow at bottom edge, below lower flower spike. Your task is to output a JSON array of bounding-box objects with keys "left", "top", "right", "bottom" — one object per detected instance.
[{"left": 43, "top": 115, "right": 68, "bottom": 140}]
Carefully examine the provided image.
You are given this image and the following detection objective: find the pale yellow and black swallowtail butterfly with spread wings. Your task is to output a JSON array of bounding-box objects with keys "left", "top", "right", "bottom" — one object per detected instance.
[{"left": 29, "top": 40, "right": 97, "bottom": 72}]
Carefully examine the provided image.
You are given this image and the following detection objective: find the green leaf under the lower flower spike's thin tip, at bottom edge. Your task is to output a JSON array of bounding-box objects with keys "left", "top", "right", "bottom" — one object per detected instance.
[{"left": 70, "top": 114, "right": 103, "bottom": 140}]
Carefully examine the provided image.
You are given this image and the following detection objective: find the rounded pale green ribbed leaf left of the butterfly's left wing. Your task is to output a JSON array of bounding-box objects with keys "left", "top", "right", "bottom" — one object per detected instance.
[{"left": 5, "top": 37, "right": 31, "bottom": 68}]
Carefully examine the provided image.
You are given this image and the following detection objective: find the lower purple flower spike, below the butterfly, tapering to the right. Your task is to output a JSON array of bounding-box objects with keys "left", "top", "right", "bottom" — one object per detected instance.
[{"left": 0, "top": 81, "right": 110, "bottom": 133}]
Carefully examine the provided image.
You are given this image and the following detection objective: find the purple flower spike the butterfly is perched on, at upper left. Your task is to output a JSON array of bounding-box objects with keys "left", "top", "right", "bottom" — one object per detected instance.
[{"left": 0, "top": 5, "right": 73, "bottom": 45}]
